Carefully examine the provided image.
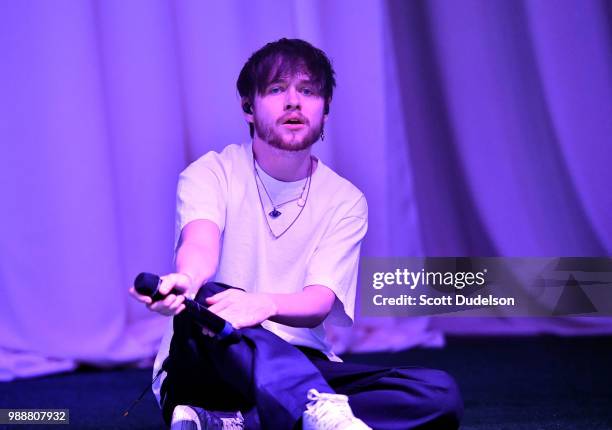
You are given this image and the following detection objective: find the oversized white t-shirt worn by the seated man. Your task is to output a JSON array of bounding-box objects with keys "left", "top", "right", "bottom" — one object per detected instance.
[{"left": 154, "top": 144, "right": 368, "bottom": 404}]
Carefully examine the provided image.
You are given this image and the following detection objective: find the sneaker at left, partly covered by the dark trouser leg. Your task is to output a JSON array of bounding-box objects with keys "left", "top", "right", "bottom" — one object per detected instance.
[{"left": 170, "top": 405, "right": 244, "bottom": 430}]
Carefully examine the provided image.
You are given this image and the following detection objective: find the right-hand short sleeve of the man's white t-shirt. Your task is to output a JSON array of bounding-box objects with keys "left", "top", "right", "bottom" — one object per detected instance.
[{"left": 305, "top": 194, "right": 368, "bottom": 326}]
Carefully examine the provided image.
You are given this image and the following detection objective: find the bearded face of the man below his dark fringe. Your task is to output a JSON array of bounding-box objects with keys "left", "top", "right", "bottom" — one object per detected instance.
[{"left": 252, "top": 73, "right": 326, "bottom": 151}]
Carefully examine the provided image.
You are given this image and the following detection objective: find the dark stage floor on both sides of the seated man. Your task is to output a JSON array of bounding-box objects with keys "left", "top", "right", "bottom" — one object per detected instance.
[{"left": 0, "top": 337, "right": 612, "bottom": 430}]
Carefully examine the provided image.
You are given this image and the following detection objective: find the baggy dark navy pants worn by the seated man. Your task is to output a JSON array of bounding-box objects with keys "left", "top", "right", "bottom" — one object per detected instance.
[{"left": 161, "top": 282, "right": 463, "bottom": 430}]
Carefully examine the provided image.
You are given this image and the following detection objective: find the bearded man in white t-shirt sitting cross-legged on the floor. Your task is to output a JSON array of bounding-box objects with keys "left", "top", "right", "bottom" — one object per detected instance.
[{"left": 131, "top": 39, "right": 462, "bottom": 430}]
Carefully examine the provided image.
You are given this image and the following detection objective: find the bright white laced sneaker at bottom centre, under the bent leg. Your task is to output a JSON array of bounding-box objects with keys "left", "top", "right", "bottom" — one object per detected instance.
[{"left": 302, "top": 388, "right": 372, "bottom": 430}]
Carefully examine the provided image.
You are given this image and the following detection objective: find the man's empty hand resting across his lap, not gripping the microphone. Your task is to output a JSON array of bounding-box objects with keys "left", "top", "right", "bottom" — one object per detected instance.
[{"left": 206, "top": 288, "right": 277, "bottom": 329}]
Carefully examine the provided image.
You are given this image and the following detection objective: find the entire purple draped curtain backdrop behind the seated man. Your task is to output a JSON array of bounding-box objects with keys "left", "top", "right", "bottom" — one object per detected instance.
[{"left": 0, "top": 0, "right": 612, "bottom": 379}]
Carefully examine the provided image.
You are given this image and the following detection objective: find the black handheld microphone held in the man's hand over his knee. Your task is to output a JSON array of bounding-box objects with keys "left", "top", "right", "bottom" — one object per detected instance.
[{"left": 134, "top": 272, "right": 241, "bottom": 343}]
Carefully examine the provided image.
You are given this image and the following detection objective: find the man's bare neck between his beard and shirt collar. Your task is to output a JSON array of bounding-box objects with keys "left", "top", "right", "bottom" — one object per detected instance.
[{"left": 253, "top": 137, "right": 316, "bottom": 182}]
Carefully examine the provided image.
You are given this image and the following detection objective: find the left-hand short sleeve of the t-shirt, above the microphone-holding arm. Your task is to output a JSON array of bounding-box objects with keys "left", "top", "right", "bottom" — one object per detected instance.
[{"left": 175, "top": 152, "right": 229, "bottom": 249}]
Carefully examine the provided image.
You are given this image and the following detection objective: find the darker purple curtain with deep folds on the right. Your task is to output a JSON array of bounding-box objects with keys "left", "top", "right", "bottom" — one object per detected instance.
[{"left": 388, "top": 0, "right": 612, "bottom": 334}]
